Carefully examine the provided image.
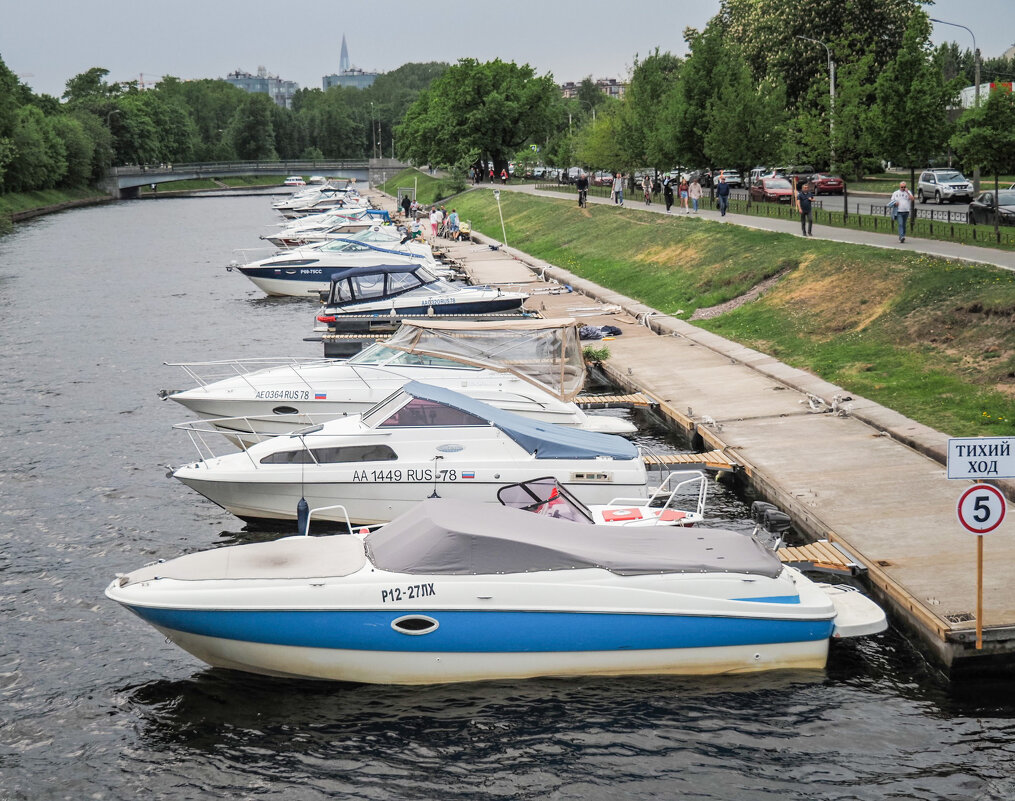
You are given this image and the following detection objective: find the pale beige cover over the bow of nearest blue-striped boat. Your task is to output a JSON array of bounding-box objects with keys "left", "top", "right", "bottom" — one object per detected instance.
[{"left": 121, "top": 535, "right": 366, "bottom": 586}]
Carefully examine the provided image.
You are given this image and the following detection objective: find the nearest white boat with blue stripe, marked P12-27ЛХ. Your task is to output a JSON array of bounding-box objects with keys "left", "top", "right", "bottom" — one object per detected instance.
[{"left": 100, "top": 499, "right": 886, "bottom": 684}]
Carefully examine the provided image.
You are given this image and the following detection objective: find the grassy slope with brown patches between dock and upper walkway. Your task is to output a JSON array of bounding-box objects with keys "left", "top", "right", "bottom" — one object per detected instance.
[{"left": 455, "top": 191, "right": 1015, "bottom": 436}]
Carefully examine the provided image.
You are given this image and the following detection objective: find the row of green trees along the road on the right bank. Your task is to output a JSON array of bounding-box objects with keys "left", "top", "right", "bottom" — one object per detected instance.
[{"left": 396, "top": 0, "right": 1015, "bottom": 190}]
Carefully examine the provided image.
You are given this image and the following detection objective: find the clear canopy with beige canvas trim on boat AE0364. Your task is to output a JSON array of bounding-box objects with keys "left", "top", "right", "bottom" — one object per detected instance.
[{"left": 385, "top": 317, "right": 586, "bottom": 402}]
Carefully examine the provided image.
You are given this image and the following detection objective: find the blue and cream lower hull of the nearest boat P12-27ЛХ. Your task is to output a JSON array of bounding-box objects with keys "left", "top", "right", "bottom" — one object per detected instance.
[{"left": 124, "top": 608, "right": 830, "bottom": 684}]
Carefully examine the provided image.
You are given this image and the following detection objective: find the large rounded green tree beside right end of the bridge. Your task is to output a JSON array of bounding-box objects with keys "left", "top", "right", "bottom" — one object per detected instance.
[{"left": 395, "top": 59, "right": 559, "bottom": 173}]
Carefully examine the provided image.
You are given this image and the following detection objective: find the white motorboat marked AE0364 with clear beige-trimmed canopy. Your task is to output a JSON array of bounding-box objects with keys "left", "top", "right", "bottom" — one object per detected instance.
[{"left": 160, "top": 318, "right": 635, "bottom": 442}]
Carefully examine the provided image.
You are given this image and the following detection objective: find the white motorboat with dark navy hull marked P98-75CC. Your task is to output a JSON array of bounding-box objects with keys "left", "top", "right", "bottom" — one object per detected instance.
[{"left": 235, "top": 232, "right": 438, "bottom": 298}]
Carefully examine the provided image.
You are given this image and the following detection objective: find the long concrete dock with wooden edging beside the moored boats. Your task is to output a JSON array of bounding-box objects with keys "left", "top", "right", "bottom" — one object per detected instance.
[{"left": 369, "top": 188, "right": 1015, "bottom": 677}]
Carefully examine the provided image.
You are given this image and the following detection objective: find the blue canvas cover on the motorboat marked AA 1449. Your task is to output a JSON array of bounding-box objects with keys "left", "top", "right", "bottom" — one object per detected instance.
[{"left": 399, "top": 381, "right": 638, "bottom": 459}]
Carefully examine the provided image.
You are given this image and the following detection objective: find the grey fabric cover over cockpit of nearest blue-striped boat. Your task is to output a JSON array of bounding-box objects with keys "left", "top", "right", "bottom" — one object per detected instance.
[{"left": 365, "top": 498, "right": 783, "bottom": 578}]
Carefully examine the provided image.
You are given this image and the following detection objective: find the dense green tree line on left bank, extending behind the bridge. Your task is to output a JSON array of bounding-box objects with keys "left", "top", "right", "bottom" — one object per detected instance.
[{"left": 0, "top": 59, "right": 448, "bottom": 194}]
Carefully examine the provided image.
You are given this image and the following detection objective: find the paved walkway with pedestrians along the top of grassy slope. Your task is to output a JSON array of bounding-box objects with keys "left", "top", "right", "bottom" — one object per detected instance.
[{"left": 505, "top": 184, "right": 1015, "bottom": 270}]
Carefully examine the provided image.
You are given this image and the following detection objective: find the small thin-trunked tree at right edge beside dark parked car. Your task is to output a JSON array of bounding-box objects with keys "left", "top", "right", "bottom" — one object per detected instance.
[{"left": 951, "top": 86, "right": 1015, "bottom": 231}]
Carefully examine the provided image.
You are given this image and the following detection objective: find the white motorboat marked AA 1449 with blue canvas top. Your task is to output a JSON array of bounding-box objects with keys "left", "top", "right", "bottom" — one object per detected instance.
[{"left": 174, "top": 382, "right": 647, "bottom": 525}]
